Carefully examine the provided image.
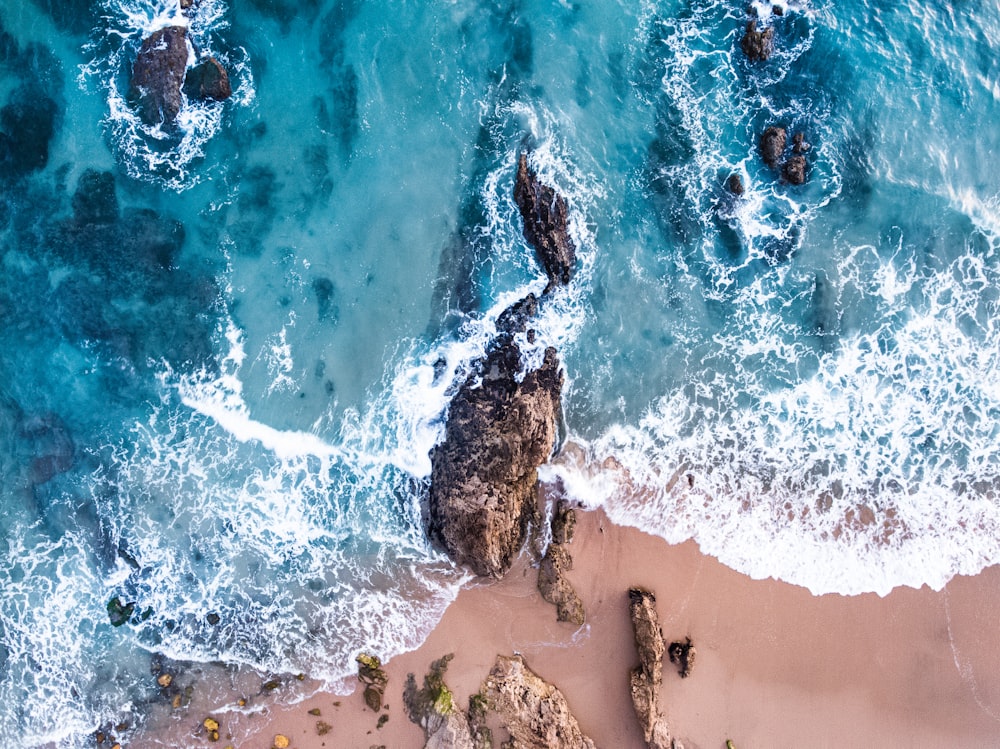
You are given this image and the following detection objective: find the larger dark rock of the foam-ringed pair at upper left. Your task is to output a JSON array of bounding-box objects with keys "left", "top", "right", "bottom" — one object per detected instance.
[{"left": 131, "top": 26, "right": 188, "bottom": 126}]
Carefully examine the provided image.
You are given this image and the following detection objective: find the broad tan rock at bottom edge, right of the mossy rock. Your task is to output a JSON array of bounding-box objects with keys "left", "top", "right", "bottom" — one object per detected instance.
[{"left": 483, "top": 655, "right": 594, "bottom": 749}]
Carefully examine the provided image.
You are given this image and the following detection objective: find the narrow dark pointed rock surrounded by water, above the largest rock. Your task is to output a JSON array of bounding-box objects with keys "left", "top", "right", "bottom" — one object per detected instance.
[{"left": 514, "top": 152, "right": 576, "bottom": 292}]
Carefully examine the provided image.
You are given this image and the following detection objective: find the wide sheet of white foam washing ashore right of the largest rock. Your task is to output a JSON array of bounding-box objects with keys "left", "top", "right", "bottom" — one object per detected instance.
[{"left": 549, "top": 248, "right": 1000, "bottom": 595}]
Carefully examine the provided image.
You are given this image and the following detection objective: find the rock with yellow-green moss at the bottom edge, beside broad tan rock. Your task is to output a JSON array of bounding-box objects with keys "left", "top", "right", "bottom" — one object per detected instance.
[{"left": 403, "top": 654, "right": 491, "bottom": 749}]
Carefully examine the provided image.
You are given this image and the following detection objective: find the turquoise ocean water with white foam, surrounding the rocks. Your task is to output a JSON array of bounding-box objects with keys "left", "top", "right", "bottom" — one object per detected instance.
[{"left": 0, "top": 0, "right": 1000, "bottom": 747}]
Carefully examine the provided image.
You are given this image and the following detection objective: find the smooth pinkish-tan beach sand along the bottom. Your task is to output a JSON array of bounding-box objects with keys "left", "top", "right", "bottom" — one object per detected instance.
[{"left": 154, "top": 502, "right": 1000, "bottom": 749}]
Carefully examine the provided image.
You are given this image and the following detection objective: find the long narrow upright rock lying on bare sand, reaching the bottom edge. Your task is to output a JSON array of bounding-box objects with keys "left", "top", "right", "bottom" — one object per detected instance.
[{"left": 628, "top": 588, "right": 676, "bottom": 749}]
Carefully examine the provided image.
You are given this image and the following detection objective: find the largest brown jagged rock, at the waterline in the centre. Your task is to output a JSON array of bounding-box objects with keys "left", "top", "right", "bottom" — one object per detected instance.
[{"left": 428, "top": 326, "right": 563, "bottom": 578}]
